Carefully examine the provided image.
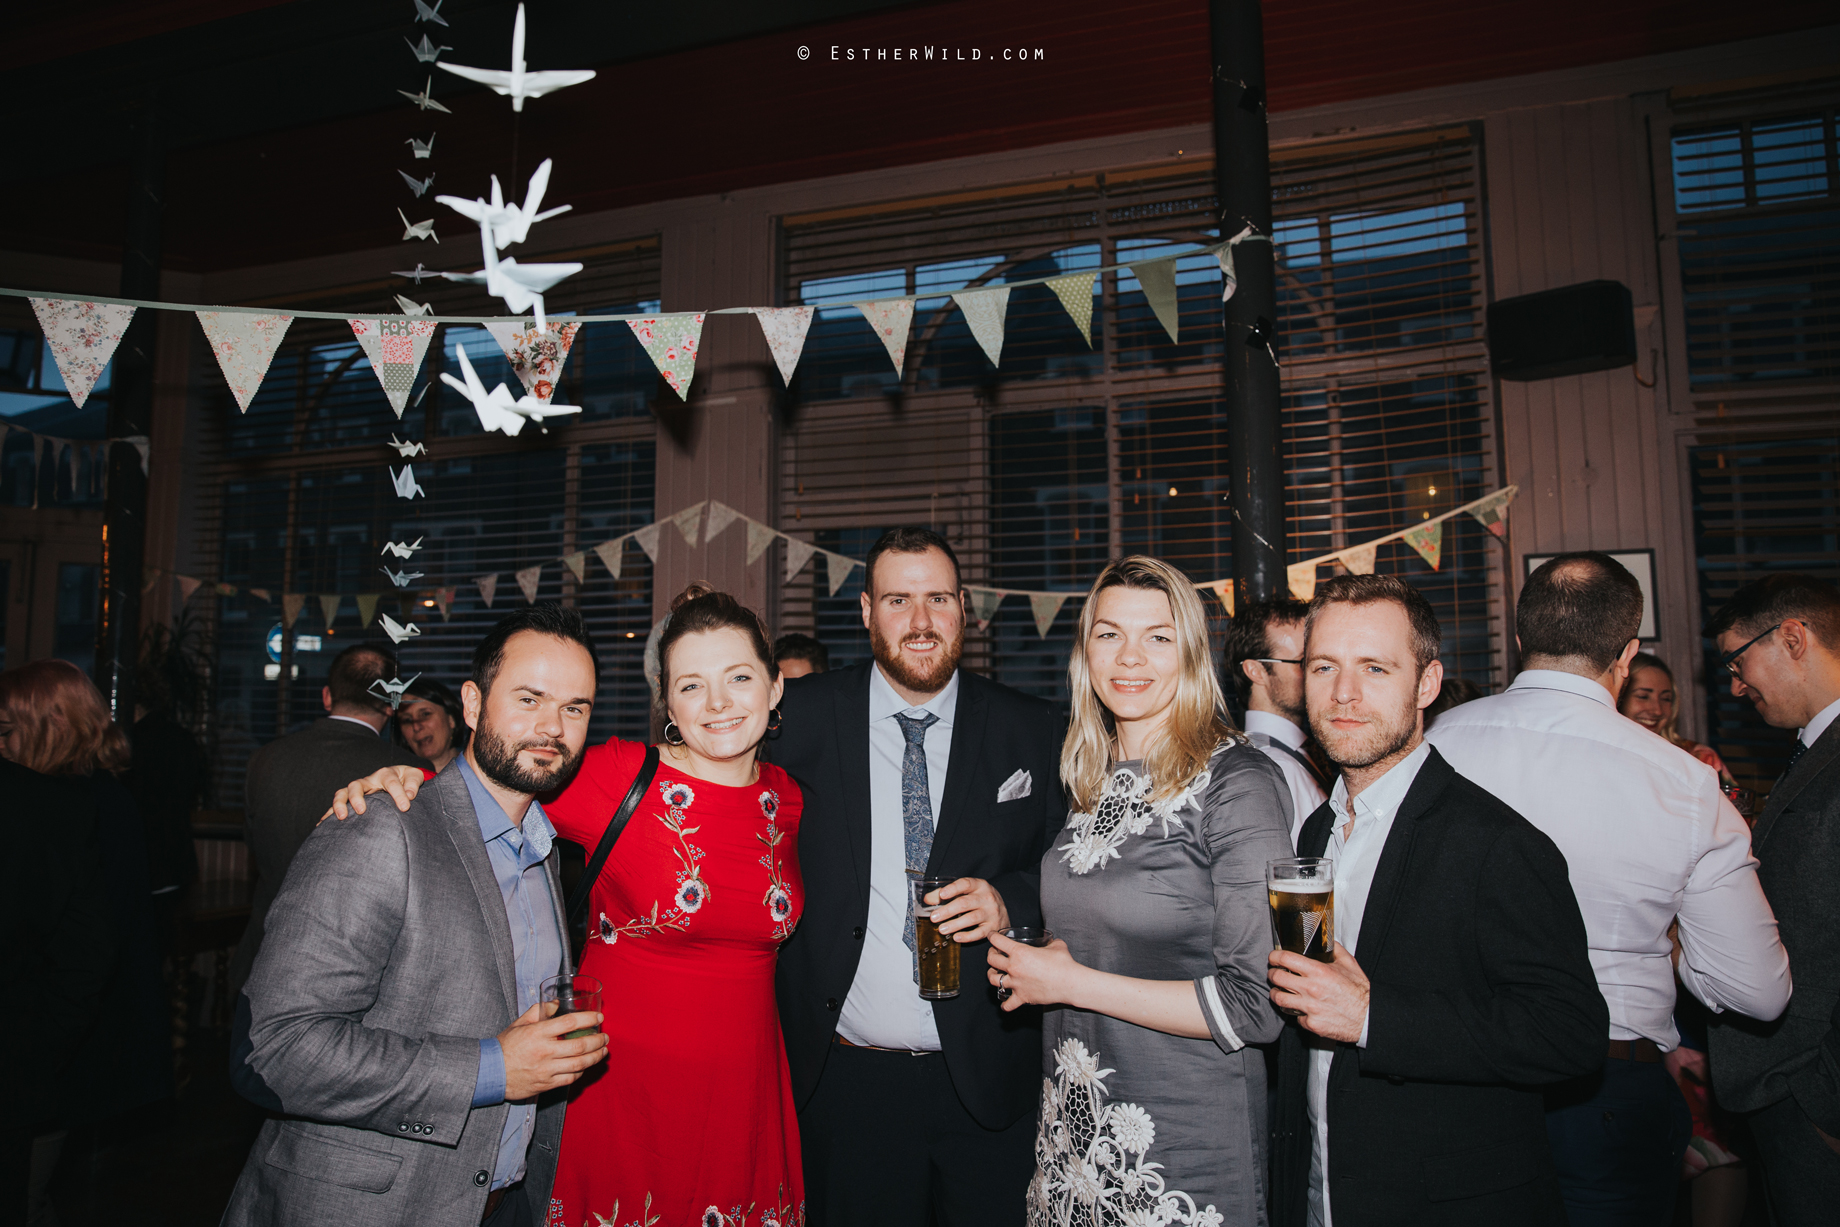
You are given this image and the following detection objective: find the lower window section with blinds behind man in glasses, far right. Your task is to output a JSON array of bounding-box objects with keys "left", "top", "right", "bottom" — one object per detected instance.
[{"left": 1689, "top": 434, "right": 1840, "bottom": 789}]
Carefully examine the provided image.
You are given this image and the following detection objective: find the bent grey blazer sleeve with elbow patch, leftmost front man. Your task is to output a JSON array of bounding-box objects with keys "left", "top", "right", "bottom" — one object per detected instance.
[{"left": 232, "top": 806, "right": 480, "bottom": 1146}]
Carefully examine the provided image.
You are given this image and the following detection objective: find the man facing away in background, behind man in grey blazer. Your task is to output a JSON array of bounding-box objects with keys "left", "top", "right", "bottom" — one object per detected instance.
[{"left": 230, "top": 644, "right": 429, "bottom": 997}]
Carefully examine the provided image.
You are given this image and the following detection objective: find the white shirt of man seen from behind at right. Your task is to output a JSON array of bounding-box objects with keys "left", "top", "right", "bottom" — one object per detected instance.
[{"left": 1430, "top": 670, "right": 1790, "bottom": 1050}]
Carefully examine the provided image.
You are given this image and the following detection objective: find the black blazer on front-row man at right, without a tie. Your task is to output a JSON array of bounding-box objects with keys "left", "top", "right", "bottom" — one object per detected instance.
[{"left": 1271, "top": 749, "right": 1610, "bottom": 1227}]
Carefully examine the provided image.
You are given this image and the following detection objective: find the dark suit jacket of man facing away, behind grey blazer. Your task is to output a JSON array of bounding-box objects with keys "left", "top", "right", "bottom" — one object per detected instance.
[{"left": 230, "top": 717, "right": 431, "bottom": 997}]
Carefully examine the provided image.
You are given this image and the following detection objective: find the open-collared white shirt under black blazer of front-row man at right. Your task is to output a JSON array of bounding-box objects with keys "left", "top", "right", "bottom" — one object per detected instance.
[{"left": 1308, "top": 741, "right": 1432, "bottom": 1227}]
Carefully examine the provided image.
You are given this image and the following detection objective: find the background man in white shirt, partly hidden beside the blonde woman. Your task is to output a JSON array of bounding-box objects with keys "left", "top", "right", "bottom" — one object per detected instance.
[{"left": 1227, "top": 600, "right": 1328, "bottom": 848}]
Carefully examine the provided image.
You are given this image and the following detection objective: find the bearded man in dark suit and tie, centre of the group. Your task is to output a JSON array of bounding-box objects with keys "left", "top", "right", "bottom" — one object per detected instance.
[{"left": 771, "top": 528, "right": 1067, "bottom": 1227}]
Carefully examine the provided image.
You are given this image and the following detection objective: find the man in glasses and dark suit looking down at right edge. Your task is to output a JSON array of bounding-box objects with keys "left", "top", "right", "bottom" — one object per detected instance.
[{"left": 1709, "top": 574, "right": 1840, "bottom": 1227}]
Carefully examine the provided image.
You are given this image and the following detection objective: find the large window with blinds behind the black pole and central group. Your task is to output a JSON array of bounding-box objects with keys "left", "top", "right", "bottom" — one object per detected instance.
[{"left": 780, "top": 127, "right": 1501, "bottom": 699}]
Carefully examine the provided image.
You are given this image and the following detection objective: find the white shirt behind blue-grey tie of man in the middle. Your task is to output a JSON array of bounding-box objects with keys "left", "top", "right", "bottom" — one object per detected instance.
[{"left": 837, "top": 664, "right": 977, "bottom": 1052}]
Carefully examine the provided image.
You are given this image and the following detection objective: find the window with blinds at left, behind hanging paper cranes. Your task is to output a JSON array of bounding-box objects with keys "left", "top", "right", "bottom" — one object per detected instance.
[{"left": 193, "top": 239, "right": 659, "bottom": 808}]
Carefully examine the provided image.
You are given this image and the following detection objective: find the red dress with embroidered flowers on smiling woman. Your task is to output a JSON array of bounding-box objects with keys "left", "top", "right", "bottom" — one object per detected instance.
[{"left": 543, "top": 741, "right": 804, "bottom": 1227}]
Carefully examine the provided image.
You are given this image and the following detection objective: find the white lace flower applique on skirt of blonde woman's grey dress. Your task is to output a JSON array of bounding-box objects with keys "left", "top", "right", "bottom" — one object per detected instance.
[{"left": 1029, "top": 1039, "right": 1225, "bottom": 1227}]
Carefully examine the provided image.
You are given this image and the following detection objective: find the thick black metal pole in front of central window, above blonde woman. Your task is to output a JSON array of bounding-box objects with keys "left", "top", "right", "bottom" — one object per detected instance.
[{"left": 1209, "top": 0, "right": 1288, "bottom": 602}]
